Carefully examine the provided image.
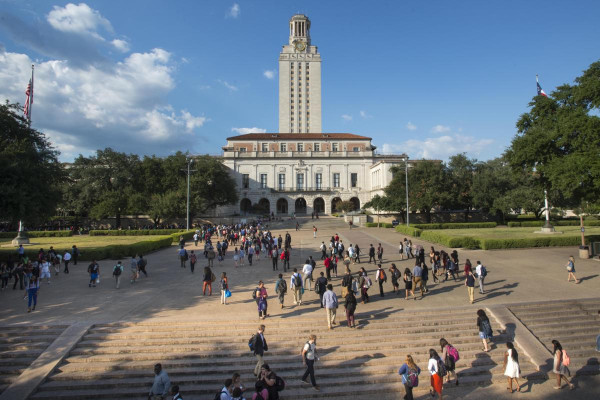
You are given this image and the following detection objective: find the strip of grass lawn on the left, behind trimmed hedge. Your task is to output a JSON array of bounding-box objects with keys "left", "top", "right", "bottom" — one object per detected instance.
[{"left": 0, "top": 235, "right": 168, "bottom": 251}]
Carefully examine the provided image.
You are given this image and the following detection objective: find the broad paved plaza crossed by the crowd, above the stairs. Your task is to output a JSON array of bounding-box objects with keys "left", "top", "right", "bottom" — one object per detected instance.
[{"left": 0, "top": 218, "right": 600, "bottom": 399}]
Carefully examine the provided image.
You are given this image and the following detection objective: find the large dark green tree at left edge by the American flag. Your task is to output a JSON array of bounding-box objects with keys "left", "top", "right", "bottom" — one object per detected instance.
[{"left": 0, "top": 102, "right": 64, "bottom": 226}]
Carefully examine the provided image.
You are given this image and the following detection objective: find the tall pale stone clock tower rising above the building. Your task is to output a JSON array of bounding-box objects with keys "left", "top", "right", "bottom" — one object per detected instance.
[{"left": 279, "top": 14, "right": 321, "bottom": 133}]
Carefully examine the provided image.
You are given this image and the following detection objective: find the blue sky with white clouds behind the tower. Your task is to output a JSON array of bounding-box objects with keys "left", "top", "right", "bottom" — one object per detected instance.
[{"left": 0, "top": 0, "right": 600, "bottom": 161}]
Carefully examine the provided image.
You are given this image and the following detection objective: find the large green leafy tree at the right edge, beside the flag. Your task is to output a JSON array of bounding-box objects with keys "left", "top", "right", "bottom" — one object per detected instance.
[{"left": 506, "top": 61, "right": 600, "bottom": 205}]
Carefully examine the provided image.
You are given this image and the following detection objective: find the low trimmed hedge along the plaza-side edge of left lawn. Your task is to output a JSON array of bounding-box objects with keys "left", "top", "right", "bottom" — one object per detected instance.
[{"left": 0, "top": 236, "right": 173, "bottom": 261}]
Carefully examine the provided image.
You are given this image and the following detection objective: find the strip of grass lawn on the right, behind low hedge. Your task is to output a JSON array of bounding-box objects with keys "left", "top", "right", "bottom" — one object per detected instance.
[{"left": 435, "top": 226, "right": 600, "bottom": 239}]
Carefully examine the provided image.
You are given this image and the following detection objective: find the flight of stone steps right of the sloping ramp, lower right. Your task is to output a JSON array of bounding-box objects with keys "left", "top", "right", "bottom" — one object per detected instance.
[{"left": 509, "top": 299, "right": 600, "bottom": 375}]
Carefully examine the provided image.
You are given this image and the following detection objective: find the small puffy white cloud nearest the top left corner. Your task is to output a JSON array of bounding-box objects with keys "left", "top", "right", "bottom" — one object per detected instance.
[{"left": 46, "top": 3, "right": 112, "bottom": 39}]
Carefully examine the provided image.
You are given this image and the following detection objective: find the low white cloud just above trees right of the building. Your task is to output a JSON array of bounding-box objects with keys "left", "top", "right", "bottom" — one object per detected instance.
[{"left": 382, "top": 134, "right": 494, "bottom": 160}]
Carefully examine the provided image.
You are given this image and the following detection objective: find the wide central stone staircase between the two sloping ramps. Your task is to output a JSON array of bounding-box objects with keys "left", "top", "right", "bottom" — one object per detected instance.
[{"left": 32, "top": 305, "right": 544, "bottom": 400}]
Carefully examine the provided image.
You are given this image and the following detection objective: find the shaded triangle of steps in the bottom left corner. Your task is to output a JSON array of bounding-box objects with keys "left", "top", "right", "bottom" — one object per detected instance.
[{"left": 0, "top": 325, "right": 66, "bottom": 393}]
